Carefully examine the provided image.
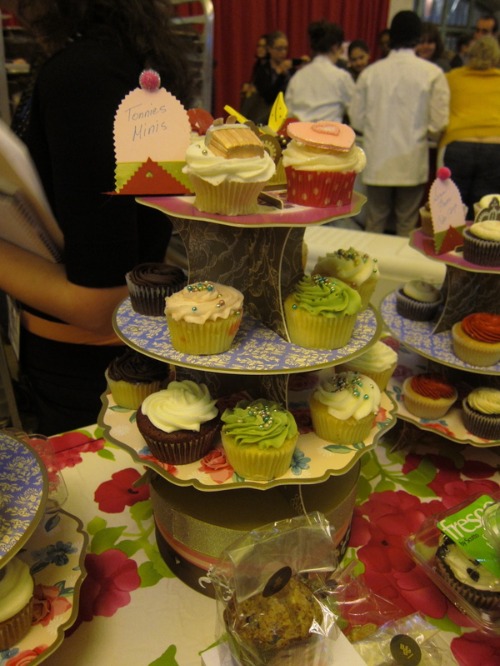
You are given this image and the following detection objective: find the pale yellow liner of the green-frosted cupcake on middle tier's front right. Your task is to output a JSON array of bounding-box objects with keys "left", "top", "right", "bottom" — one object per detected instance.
[{"left": 284, "top": 297, "right": 357, "bottom": 349}]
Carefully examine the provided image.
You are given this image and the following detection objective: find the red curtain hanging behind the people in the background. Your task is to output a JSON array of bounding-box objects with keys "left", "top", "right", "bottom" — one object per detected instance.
[{"left": 207, "top": 0, "right": 390, "bottom": 117}]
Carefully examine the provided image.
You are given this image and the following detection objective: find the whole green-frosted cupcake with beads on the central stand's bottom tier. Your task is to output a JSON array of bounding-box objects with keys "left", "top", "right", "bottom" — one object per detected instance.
[{"left": 221, "top": 399, "right": 299, "bottom": 481}]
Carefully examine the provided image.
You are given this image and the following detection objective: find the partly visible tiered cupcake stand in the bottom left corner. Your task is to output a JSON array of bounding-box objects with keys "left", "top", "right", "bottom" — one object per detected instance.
[{"left": 0, "top": 431, "right": 87, "bottom": 664}]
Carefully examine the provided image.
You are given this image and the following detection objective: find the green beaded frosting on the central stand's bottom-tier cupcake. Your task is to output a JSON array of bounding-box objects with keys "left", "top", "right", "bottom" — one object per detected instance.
[{"left": 222, "top": 400, "right": 298, "bottom": 449}]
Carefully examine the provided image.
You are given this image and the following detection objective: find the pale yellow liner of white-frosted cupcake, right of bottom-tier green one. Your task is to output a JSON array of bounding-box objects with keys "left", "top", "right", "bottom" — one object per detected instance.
[{"left": 310, "top": 398, "right": 376, "bottom": 445}]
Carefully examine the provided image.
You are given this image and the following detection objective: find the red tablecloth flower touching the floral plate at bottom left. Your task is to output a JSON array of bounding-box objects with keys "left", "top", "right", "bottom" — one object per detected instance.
[{"left": 73, "top": 548, "right": 141, "bottom": 630}]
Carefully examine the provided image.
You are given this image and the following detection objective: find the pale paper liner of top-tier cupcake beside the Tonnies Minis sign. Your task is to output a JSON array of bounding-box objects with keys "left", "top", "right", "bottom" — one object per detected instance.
[{"left": 189, "top": 174, "right": 267, "bottom": 215}]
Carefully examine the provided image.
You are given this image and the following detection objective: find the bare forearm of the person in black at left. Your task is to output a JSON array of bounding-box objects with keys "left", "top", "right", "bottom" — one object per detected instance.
[{"left": 0, "top": 240, "right": 127, "bottom": 335}]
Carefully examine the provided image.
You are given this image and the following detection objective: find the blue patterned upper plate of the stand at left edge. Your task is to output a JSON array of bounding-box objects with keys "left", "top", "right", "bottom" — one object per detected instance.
[{"left": 0, "top": 431, "right": 48, "bottom": 567}]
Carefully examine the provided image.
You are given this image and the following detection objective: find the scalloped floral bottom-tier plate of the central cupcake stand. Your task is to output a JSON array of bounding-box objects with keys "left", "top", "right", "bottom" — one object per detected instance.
[{"left": 98, "top": 393, "right": 396, "bottom": 491}]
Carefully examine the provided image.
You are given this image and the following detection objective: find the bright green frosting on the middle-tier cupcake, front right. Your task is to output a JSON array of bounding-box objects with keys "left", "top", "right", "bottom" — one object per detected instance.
[{"left": 292, "top": 275, "right": 361, "bottom": 317}]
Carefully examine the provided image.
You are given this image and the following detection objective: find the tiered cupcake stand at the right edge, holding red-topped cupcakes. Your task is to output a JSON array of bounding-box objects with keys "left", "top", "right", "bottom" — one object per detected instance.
[{"left": 380, "top": 230, "right": 500, "bottom": 447}]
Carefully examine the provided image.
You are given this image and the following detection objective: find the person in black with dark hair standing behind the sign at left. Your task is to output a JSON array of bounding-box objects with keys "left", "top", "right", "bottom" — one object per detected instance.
[{"left": 0, "top": 0, "right": 192, "bottom": 435}]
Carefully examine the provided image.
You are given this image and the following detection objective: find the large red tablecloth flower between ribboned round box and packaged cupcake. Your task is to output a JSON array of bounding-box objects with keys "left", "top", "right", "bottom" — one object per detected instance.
[{"left": 350, "top": 491, "right": 470, "bottom": 626}]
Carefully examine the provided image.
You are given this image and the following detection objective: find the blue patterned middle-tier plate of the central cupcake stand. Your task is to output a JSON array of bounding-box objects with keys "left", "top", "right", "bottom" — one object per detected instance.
[{"left": 113, "top": 298, "right": 382, "bottom": 375}]
